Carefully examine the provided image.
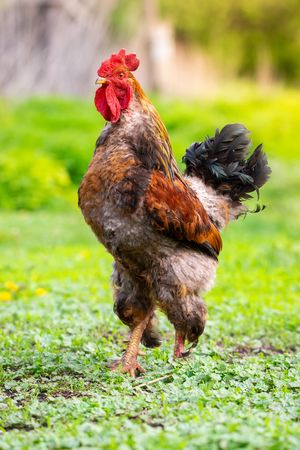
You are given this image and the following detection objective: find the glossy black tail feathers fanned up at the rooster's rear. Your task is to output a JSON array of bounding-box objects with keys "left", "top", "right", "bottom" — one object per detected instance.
[{"left": 183, "top": 124, "right": 271, "bottom": 202}]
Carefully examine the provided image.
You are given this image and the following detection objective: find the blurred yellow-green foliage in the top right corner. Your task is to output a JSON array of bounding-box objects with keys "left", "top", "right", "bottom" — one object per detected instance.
[{"left": 159, "top": 0, "right": 300, "bottom": 82}]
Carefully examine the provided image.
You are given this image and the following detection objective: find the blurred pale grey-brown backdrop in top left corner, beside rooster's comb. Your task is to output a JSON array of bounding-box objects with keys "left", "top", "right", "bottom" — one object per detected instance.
[{"left": 0, "top": 0, "right": 117, "bottom": 95}]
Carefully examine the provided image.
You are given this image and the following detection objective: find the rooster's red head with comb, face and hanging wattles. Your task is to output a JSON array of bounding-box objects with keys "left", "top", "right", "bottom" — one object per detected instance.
[{"left": 95, "top": 49, "right": 140, "bottom": 123}]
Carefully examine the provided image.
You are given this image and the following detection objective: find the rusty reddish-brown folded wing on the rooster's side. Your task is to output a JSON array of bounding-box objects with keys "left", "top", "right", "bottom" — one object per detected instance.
[{"left": 145, "top": 171, "right": 222, "bottom": 255}]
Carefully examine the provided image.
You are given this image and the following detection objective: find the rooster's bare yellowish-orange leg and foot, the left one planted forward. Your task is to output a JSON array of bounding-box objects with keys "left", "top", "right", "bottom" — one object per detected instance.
[{"left": 111, "top": 316, "right": 149, "bottom": 377}]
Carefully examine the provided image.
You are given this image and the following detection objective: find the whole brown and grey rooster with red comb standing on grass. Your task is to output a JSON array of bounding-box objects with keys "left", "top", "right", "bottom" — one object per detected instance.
[{"left": 79, "top": 49, "right": 271, "bottom": 376}]
